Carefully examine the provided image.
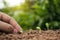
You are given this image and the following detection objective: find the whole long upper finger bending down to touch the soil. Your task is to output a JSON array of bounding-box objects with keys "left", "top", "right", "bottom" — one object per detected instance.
[{"left": 0, "top": 12, "right": 23, "bottom": 32}]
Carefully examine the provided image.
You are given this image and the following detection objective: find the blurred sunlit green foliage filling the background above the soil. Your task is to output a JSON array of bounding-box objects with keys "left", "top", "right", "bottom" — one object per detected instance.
[{"left": 0, "top": 0, "right": 60, "bottom": 30}]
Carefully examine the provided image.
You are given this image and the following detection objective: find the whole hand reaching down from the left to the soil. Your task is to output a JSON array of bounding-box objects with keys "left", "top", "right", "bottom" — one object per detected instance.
[{"left": 0, "top": 12, "right": 23, "bottom": 33}]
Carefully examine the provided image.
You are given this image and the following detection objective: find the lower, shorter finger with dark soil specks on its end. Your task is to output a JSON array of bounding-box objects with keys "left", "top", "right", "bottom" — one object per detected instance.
[{"left": 0, "top": 21, "right": 14, "bottom": 33}]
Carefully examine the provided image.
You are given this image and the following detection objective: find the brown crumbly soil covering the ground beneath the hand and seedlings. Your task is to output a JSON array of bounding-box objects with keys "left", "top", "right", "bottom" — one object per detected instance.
[{"left": 0, "top": 30, "right": 60, "bottom": 40}]
